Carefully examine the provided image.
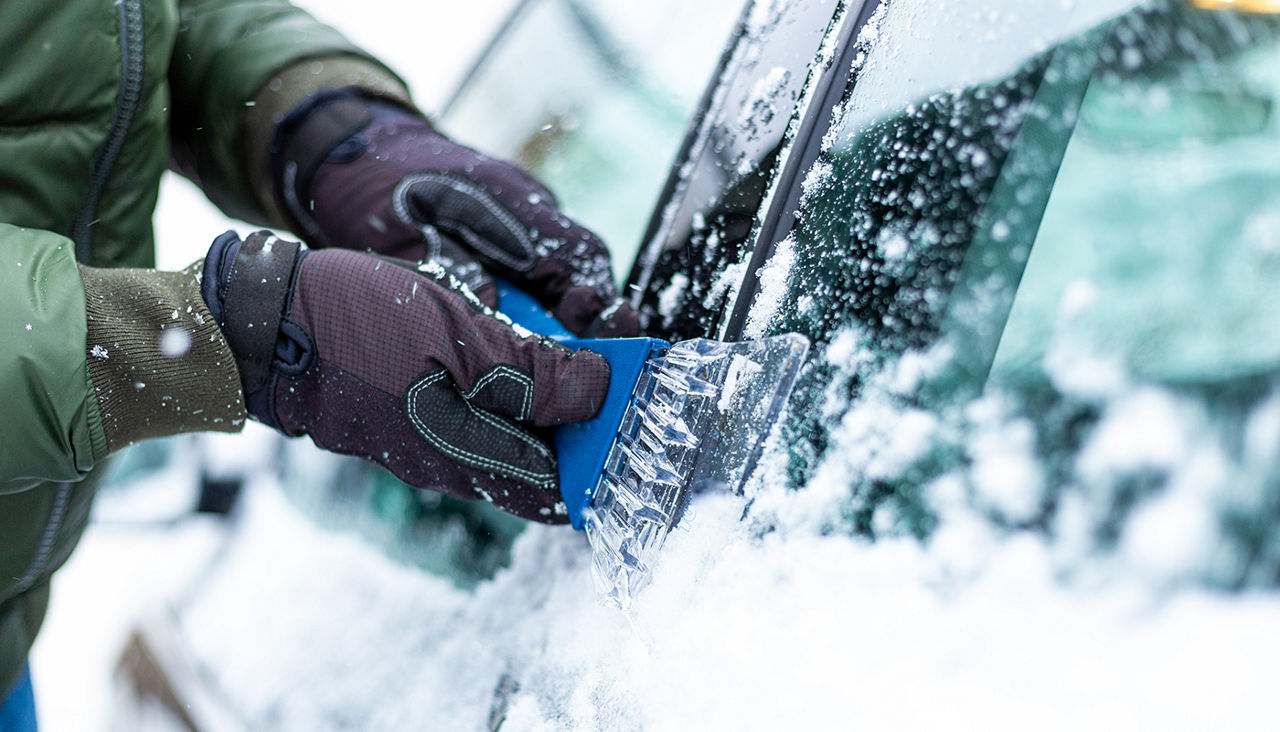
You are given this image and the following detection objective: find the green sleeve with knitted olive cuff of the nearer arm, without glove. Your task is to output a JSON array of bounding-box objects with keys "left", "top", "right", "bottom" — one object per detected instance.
[{"left": 0, "top": 224, "right": 244, "bottom": 493}]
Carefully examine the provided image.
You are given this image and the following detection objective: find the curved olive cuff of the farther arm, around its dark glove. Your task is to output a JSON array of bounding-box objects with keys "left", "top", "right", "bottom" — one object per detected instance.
[{"left": 244, "top": 56, "right": 413, "bottom": 229}]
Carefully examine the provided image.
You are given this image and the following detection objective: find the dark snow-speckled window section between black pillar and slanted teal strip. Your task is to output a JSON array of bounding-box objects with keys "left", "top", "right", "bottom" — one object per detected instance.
[{"left": 749, "top": 0, "right": 1141, "bottom": 363}]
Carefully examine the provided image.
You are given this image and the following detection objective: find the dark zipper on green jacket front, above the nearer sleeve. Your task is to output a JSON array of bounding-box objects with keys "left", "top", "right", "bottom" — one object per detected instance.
[{"left": 72, "top": 0, "right": 146, "bottom": 264}]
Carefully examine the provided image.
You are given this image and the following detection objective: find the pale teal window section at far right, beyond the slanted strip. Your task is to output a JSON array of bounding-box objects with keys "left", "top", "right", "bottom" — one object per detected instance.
[{"left": 993, "top": 17, "right": 1280, "bottom": 383}]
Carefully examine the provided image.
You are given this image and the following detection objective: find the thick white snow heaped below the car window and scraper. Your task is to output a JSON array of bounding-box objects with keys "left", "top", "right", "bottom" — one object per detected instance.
[{"left": 170, "top": 334, "right": 1280, "bottom": 731}]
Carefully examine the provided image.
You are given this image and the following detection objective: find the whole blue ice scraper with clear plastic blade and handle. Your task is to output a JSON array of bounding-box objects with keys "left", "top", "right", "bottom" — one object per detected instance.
[{"left": 498, "top": 283, "right": 809, "bottom": 609}]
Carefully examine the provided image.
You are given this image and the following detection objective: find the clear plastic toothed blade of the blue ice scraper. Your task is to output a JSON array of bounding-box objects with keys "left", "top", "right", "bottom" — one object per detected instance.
[{"left": 586, "top": 334, "right": 809, "bottom": 609}]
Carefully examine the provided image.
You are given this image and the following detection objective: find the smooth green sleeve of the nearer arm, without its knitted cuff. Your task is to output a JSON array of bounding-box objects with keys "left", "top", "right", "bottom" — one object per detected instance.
[{"left": 0, "top": 224, "right": 106, "bottom": 494}]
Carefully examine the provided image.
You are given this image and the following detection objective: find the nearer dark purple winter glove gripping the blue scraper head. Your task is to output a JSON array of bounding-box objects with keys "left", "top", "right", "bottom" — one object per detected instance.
[{"left": 201, "top": 232, "right": 609, "bottom": 523}]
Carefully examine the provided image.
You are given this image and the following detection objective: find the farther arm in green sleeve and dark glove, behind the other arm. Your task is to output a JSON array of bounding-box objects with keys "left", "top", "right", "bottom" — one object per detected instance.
[{"left": 169, "top": 0, "right": 639, "bottom": 335}]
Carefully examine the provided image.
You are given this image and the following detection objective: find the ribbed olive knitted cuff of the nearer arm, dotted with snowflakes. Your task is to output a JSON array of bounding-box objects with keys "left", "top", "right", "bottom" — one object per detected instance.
[{"left": 81, "top": 262, "right": 244, "bottom": 452}]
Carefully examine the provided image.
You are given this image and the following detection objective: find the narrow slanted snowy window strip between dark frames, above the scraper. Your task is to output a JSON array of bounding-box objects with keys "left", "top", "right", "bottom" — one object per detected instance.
[{"left": 630, "top": 0, "right": 859, "bottom": 339}]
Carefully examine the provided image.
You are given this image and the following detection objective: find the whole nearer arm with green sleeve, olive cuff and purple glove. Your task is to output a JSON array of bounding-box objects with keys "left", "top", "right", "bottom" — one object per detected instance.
[{"left": 0, "top": 220, "right": 609, "bottom": 523}]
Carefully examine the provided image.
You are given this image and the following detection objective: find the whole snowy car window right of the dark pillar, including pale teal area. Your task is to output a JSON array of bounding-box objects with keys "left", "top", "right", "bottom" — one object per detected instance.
[{"left": 755, "top": 1, "right": 1280, "bottom": 386}]
